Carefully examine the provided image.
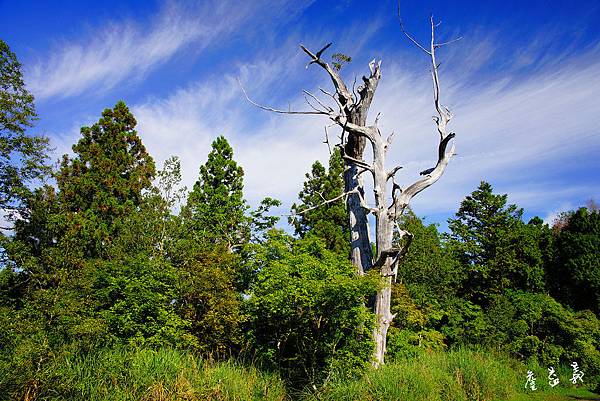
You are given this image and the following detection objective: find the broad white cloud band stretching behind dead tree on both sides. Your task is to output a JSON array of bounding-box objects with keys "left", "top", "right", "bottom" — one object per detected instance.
[{"left": 69, "top": 21, "right": 600, "bottom": 222}]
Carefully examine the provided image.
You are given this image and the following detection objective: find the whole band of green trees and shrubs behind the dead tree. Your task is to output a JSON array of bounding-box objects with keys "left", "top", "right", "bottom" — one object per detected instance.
[{"left": 0, "top": 41, "right": 600, "bottom": 399}]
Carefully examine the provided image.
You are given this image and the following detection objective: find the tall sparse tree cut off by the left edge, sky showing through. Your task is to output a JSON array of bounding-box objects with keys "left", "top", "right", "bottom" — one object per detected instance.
[{"left": 0, "top": 39, "right": 49, "bottom": 228}]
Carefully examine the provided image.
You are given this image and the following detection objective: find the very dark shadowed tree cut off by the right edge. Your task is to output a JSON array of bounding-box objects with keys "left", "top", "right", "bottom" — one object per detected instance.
[{"left": 549, "top": 208, "right": 600, "bottom": 314}]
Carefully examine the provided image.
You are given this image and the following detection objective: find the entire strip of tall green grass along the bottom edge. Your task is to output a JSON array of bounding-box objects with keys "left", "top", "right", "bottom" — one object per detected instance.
[{"left": 10, "top": 349, "right": 600, "bottom": 401}]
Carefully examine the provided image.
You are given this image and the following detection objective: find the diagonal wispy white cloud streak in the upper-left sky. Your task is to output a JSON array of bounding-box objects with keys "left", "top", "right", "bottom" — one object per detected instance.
[{"left": 27, "top": 0, "right": 310, "bottom": 100}]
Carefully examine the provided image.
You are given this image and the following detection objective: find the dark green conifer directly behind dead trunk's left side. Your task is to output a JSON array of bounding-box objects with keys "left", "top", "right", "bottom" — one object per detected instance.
[{"left": 290, "top": 148, "right": 350, "bottom": 254}]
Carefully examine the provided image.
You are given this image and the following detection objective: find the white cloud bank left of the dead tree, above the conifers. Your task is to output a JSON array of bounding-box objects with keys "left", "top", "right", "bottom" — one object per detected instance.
[{"left": 133, "top": 21, "right": 379, "bottom": 210}]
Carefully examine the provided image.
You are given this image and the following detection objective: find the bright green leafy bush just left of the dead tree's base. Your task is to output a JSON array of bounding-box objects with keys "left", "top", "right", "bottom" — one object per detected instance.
[{"left": 247, "top": 232, "right": 377, "bottom": 385}]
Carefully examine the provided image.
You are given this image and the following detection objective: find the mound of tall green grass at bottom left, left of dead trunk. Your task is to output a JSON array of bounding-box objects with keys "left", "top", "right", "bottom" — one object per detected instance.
[{"left": 26, "top": 349, "right": 286, "bottom": 401}]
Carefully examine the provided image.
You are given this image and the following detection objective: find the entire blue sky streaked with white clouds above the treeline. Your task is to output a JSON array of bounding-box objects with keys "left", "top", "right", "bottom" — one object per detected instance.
[{"left": 0, "top": 0, "right": 600, "bottom": 225}]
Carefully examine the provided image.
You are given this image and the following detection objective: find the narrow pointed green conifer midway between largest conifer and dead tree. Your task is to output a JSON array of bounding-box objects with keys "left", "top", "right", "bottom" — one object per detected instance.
[{"left": 182, "top": 136, "right": 250, "bottom": 251}]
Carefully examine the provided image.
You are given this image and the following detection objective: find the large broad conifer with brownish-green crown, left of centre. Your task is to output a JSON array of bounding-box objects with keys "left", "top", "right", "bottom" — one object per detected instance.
[{"left": 57, "top": 101, "right": 155, "bottom": 257}]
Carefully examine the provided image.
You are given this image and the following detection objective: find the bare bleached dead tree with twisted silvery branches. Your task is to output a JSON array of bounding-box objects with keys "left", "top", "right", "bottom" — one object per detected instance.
[{"left": 242, "top": 17, "right": 455, "bottom": 366}]
